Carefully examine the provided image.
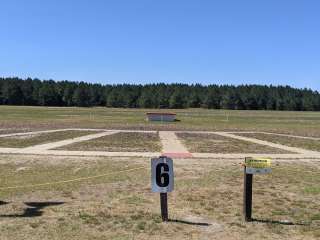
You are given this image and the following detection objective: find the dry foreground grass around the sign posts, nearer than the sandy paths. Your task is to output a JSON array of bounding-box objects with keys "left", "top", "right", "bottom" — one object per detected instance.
[{"left": 0, "top": 156, "right": 320, "bottom": 240}]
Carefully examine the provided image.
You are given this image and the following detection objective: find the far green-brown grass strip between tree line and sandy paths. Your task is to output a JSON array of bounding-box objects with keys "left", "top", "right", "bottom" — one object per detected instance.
[{"left": 0, "top": 106, "right": 320, "bottom": 137}]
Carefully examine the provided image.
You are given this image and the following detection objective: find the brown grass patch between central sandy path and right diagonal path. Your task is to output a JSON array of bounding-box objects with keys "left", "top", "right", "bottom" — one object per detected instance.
[{"left": 177, "top": 133, "right": 289, "bottom": 154}]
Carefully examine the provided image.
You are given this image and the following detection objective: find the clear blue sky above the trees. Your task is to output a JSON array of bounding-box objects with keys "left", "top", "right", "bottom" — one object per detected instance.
[{"left": 0, "top": 0, "right": 320, "bottom": 90}]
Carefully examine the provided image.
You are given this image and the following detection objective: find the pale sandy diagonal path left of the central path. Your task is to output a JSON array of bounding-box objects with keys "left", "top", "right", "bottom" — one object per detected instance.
[{"left": 21, "top": 131, "right": 117, "bottom": 154}]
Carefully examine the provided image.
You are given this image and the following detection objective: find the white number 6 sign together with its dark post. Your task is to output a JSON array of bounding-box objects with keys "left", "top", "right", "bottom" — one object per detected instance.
[{"left": 151, "top": 156, "right": 174, "bottom": 222}]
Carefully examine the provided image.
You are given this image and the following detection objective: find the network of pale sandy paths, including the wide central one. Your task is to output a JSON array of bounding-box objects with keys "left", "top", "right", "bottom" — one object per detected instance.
[{"left": 0, "top": 128, "right": 320, "bottom": 159}]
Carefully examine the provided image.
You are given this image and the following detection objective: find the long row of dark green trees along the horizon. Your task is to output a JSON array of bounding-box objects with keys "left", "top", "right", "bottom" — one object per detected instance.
[{"left": 0, "top": 78, "right": 320, "bottom": 111}]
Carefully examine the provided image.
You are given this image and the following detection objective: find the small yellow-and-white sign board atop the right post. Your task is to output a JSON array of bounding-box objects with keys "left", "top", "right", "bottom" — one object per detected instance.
[{"left": 245, "top": 158, "right": 271, "bottom": 174}]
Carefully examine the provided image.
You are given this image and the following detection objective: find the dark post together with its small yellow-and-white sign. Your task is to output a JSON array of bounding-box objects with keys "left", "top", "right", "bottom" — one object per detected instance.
[{"left": 243, "top": 158, "right": 271, "bottom": 222}]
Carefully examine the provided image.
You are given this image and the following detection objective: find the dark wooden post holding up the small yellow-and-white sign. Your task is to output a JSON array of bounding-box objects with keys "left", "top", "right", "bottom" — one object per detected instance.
[{"left": 243, "top": 167, "right": 253, "bottom": 222}]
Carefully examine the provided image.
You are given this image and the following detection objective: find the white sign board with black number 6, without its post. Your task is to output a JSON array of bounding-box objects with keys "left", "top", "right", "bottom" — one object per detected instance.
[{"left": 151, "top": 157, "right": 173, "bottom": 193}]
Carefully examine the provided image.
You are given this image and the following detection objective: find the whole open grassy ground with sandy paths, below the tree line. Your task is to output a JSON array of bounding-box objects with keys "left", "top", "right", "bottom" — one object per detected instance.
[{"left": 0, "top": 106, "right": 320, "bottom": 240}]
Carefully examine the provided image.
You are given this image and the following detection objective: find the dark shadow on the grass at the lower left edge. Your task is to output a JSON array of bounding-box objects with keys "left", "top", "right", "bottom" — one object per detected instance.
[{"left": 0, "top": 202, "right": 64, "bottom": 218}]
